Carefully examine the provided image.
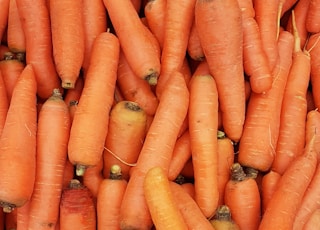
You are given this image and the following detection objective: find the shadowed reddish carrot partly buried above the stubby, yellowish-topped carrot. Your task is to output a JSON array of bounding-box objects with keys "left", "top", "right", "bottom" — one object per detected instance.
[{"left": 117, "top": 51, "right": 159, "bottom": 115}]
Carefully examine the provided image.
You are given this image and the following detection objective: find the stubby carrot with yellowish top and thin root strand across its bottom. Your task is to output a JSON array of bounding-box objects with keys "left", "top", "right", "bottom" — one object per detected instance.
[{"left": 103, "top": 101, "right": 147, "bottom": 180}]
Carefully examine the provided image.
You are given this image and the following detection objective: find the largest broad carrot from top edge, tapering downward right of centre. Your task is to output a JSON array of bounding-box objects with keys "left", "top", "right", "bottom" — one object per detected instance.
[{"left": 195, "top": 0, "right": 245, "bottom": 142}]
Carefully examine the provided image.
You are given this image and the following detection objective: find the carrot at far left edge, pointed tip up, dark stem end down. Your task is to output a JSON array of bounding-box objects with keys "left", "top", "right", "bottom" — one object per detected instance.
[{"left": 0, "top": 65, "right": 37, "bottom": 212}]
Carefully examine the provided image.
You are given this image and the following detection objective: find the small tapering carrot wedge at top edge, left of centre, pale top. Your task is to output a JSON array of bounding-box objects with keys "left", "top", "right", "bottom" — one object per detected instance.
[{"left": 144, "top": 0, "right": 167, "bottom": 50}]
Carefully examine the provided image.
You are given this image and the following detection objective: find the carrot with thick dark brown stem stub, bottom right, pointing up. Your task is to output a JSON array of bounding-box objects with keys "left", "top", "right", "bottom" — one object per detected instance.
[{"left": 224, "top": 163, "right": 261, "bottom": 230}]
